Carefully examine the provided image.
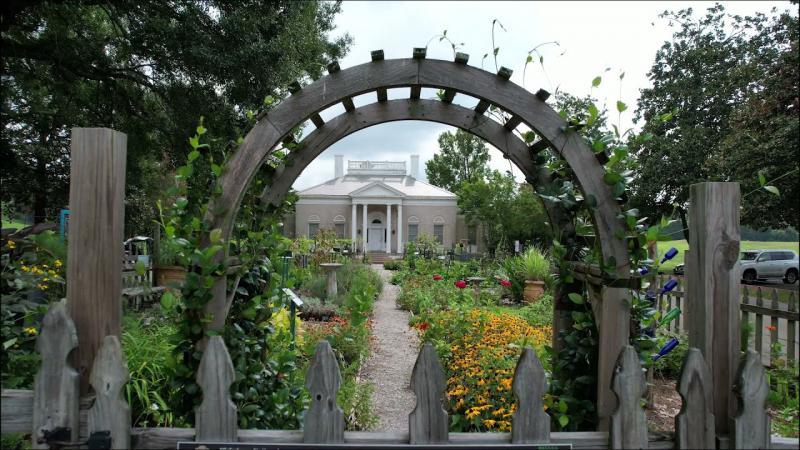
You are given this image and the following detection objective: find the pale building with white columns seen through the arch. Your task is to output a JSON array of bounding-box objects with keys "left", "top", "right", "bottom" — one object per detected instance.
[{"left": 294, "top": 155, "right": 477, "bottom": 254}]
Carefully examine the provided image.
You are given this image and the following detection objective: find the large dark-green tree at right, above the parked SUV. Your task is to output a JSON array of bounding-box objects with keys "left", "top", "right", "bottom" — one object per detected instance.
[{"left": 632, "top": 4, "right": 800, "bottom": 232}]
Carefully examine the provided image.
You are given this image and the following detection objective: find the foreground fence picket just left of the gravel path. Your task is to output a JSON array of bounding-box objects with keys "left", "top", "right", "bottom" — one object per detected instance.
[{"left": 303, "top": 340, "right": 344, "bottom": 444}]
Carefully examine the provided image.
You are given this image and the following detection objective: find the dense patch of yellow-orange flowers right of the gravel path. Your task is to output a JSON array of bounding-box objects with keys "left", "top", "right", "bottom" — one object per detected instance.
[{"left": 416, "top": 309, "right": 551, "bottom": 431}]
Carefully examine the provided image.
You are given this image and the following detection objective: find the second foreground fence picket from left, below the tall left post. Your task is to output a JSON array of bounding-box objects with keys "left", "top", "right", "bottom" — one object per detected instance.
[{"left": 89, "top": 335, "right": 131, "bottom": 449}]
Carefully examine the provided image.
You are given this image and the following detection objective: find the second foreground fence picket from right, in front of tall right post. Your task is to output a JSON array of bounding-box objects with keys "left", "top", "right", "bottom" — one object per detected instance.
[{"left": 675, "top": 347, "right": 716, "bottom": 449}]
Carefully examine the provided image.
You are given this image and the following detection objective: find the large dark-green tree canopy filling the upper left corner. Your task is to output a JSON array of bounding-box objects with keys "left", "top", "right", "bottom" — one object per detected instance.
[{"left": 0, "top": 0, "right": 350, "bottom": 233}]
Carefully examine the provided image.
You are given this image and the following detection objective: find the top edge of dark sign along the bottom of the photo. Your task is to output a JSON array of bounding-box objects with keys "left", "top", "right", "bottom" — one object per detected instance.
[{"left": 177, "top": 442, "right": 572, "bottom": 450}]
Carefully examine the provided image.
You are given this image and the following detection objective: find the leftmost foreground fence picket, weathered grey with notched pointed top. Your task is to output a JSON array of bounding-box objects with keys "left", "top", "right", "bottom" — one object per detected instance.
[{"left": 32, "top": 303, "right": 80, "bottom": 448}]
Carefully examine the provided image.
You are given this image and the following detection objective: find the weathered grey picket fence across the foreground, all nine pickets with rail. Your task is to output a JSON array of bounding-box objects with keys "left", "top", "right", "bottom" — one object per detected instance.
[{"left": 2, "top": 303, "right": 798, "bottom": 449}]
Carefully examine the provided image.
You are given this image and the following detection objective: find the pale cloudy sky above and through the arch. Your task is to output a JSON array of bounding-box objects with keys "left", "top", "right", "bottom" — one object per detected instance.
[{"left": 294, "top": 1, "right": 791, "bottom": 190}]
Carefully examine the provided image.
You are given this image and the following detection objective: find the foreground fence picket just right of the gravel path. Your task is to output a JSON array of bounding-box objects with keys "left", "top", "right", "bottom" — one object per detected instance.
[{"left": 408, "top": 342, "right": 449, "bottom": 445}]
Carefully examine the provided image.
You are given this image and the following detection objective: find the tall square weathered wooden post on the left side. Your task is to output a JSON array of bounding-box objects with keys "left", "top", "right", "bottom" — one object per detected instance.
[{"left": 67, "top": 128, "right": 128, "bottom": 394}]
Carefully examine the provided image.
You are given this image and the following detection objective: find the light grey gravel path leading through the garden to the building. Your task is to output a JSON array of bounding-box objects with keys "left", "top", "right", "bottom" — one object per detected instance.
[{"left": 363, "top": 264, "right": 419, "bottom": 431}]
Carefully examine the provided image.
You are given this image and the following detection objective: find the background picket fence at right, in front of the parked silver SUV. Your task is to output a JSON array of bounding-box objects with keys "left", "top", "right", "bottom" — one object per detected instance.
[{"left": 656, "top": 275, "right": 800, "bottom": 366}]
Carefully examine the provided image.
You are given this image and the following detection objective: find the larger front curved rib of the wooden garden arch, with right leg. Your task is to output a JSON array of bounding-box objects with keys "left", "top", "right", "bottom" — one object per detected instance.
[{"left": 206, "top": 54, "right": 630, "bottom": 428}]
